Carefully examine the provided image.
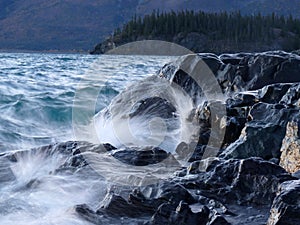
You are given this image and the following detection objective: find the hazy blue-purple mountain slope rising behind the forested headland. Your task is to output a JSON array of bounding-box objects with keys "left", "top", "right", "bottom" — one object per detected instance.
[{"left": 0, "top": 0, "right": 300, "bottom": 51}]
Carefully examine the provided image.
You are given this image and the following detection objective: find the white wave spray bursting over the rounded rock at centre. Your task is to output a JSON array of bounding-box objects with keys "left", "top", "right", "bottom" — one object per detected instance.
[{"left": 95, "top": 76, "right": 198, "bottom": 153}]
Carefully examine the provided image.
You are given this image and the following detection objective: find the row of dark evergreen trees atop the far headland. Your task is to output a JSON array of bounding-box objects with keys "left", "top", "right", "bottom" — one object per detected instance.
[{"left": 103, "top": 10, "right": 300, "bottom": 50}]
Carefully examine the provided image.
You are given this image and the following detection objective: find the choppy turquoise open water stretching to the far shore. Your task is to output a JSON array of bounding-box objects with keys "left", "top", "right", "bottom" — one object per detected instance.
[{"left": 0, "top": 53, "right": 171, "bottom": 152}]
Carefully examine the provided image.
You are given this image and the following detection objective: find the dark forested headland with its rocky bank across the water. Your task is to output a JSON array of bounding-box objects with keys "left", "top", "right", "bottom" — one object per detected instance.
[{"left": 93, "top": 11, "right": 300, "bottom": 53}]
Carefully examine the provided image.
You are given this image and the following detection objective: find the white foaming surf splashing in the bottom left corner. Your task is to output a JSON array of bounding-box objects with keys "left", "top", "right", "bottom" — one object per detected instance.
[{"left": 0, "top": 146, "right": 106, "bottom": 225}]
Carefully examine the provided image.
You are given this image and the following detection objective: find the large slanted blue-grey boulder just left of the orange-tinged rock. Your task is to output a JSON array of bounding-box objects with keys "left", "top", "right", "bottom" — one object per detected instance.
[{"left": 220, "top": 103, "right": 298, "bottom": 159}]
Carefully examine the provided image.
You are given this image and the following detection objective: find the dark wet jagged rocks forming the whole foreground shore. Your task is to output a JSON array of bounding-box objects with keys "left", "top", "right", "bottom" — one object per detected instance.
[{"left": 0, "top": 51, "right": 300, "bottom": 225}]
